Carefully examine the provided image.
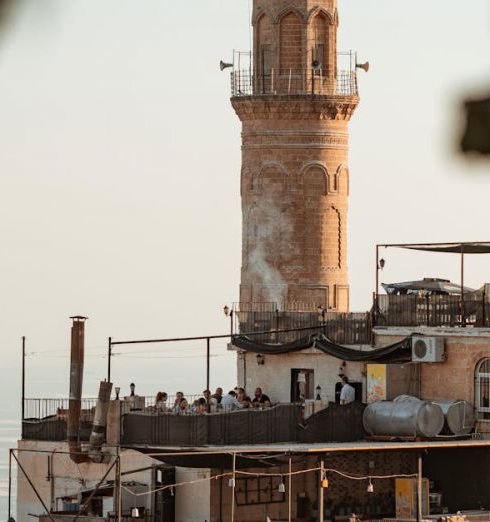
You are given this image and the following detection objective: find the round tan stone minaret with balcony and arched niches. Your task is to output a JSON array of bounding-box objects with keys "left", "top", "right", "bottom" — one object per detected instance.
[{"left": 232, "top": 0, "right": 359, "bottom": 312}]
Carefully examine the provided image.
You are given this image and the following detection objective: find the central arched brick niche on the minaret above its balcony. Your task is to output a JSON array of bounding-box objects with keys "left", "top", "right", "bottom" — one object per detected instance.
[{"left": 279, "top": 11, "right": 303, "bottom": 74}]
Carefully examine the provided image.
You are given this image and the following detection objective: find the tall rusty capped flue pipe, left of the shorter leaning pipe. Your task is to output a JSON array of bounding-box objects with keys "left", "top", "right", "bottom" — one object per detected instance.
[{"left": 67, "top": 316, "right": 88, "bottom": 464}]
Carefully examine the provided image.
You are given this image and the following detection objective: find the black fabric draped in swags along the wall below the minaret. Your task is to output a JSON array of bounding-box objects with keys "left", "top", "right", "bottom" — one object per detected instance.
[{"left": 232, "top": 335, "right": 412, "bottom": 364}]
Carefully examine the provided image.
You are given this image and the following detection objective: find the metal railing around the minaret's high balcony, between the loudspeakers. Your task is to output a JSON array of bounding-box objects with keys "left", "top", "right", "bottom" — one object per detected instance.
[{"left": 231, "top": 69, "right": 359, "bottom": 97}]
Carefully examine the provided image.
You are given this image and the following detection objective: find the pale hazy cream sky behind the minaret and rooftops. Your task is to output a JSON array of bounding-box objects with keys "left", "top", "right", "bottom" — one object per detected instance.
[{"left": 0, "top": 0, "right": 490, "bottom": 396}]
